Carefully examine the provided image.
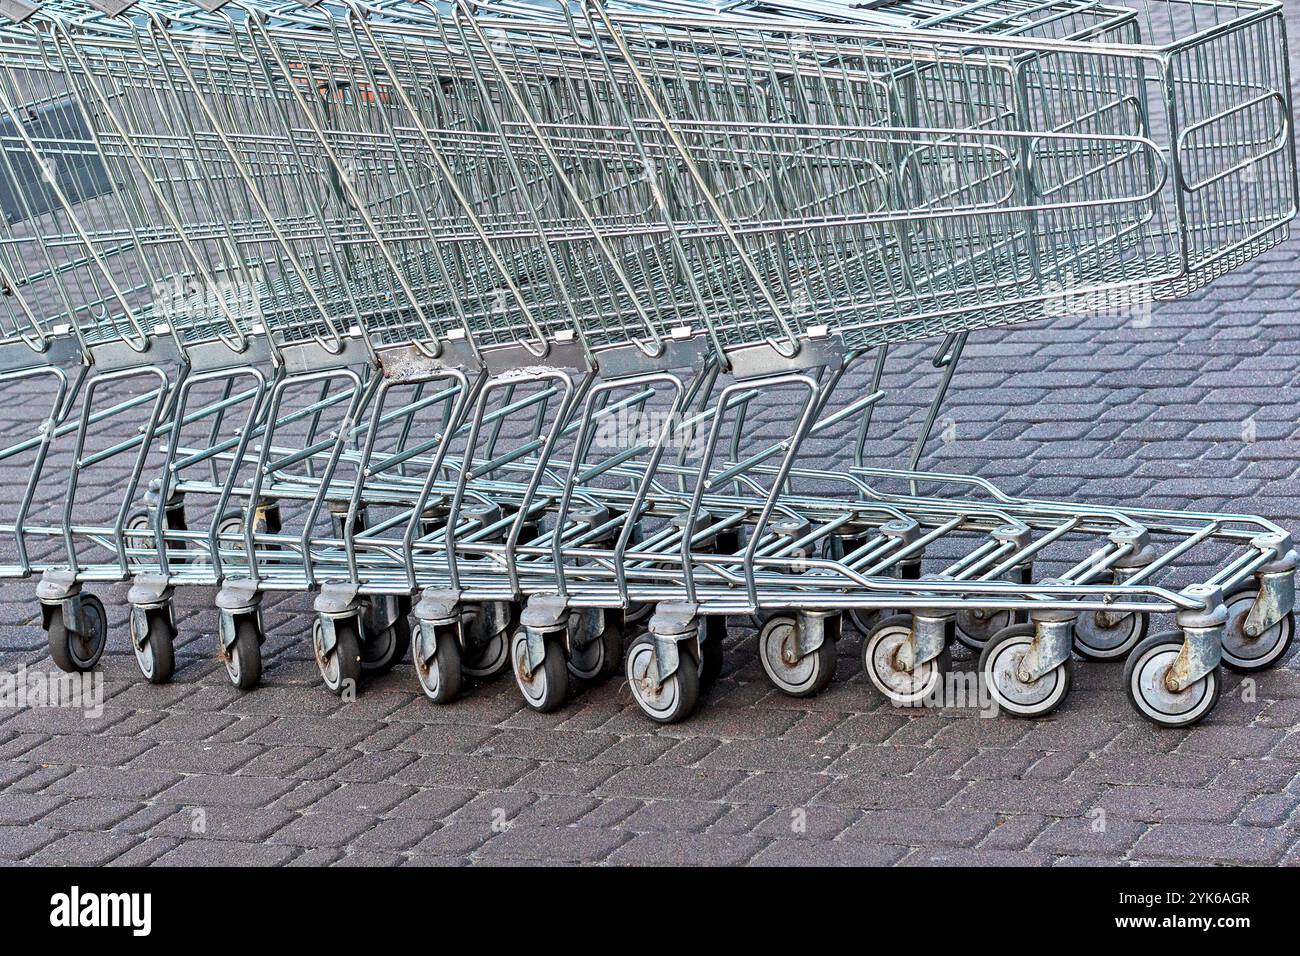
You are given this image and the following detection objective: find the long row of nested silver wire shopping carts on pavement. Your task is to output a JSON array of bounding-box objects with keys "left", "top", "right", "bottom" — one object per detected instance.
[{"left": 7, "top": 4, "right": 1295, "bottom": 724}]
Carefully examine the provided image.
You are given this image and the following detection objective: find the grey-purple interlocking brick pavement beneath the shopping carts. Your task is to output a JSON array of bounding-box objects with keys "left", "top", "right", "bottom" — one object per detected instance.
[{"left": 0, "top": 16, "right": 1300, "bottom": 865}]
